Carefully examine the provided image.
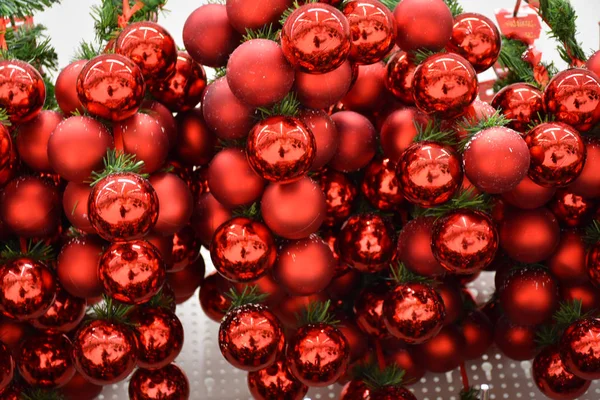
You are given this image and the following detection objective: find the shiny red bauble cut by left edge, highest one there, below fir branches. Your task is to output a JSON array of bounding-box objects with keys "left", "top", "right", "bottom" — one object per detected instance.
[{"left": 0, "top": 60, "right": 46, "bottom": 124}]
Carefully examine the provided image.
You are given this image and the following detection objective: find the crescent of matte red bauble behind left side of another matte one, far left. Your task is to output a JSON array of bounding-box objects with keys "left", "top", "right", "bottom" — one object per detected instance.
[{"left": 16, "top": 110, "right": 63, "bottom": 172}]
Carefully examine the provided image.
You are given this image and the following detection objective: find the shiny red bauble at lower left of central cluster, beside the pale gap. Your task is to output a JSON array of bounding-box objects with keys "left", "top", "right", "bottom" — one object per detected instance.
[{"left": 219, "top": 304, "right": 285, "bottom": 371}]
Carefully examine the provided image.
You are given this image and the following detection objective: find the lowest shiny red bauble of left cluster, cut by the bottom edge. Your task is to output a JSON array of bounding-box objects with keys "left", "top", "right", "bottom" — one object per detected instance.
[{"left": 129, "top": 364, "right": 190, "bottom": 400}]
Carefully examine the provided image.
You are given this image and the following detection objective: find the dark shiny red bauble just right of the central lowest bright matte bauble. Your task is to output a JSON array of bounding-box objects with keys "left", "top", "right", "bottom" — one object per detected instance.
[{"left": 339, "top": 214, "right": 396, "bottom": 273}]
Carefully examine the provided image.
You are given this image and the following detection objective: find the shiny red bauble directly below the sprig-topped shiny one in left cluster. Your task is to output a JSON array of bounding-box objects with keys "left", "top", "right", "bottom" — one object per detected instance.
[{"left": 98, "top": 240, "right": 167, "bottom": 304}]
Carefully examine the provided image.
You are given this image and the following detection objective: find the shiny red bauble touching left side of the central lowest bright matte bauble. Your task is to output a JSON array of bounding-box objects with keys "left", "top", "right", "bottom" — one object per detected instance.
[{"left": 210, "top": 217, "right": 277, "bottom": 282}]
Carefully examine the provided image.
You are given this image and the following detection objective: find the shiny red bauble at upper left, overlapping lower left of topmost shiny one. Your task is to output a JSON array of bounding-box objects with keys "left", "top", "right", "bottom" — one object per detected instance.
[{"left": 77, "top": 54, "right": 146, "bottom": 121}]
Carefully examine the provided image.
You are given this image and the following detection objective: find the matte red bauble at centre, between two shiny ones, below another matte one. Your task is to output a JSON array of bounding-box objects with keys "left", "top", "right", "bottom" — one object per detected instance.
[{"left": 273, "top": 235, "right": 335, "bottom": 296}]
